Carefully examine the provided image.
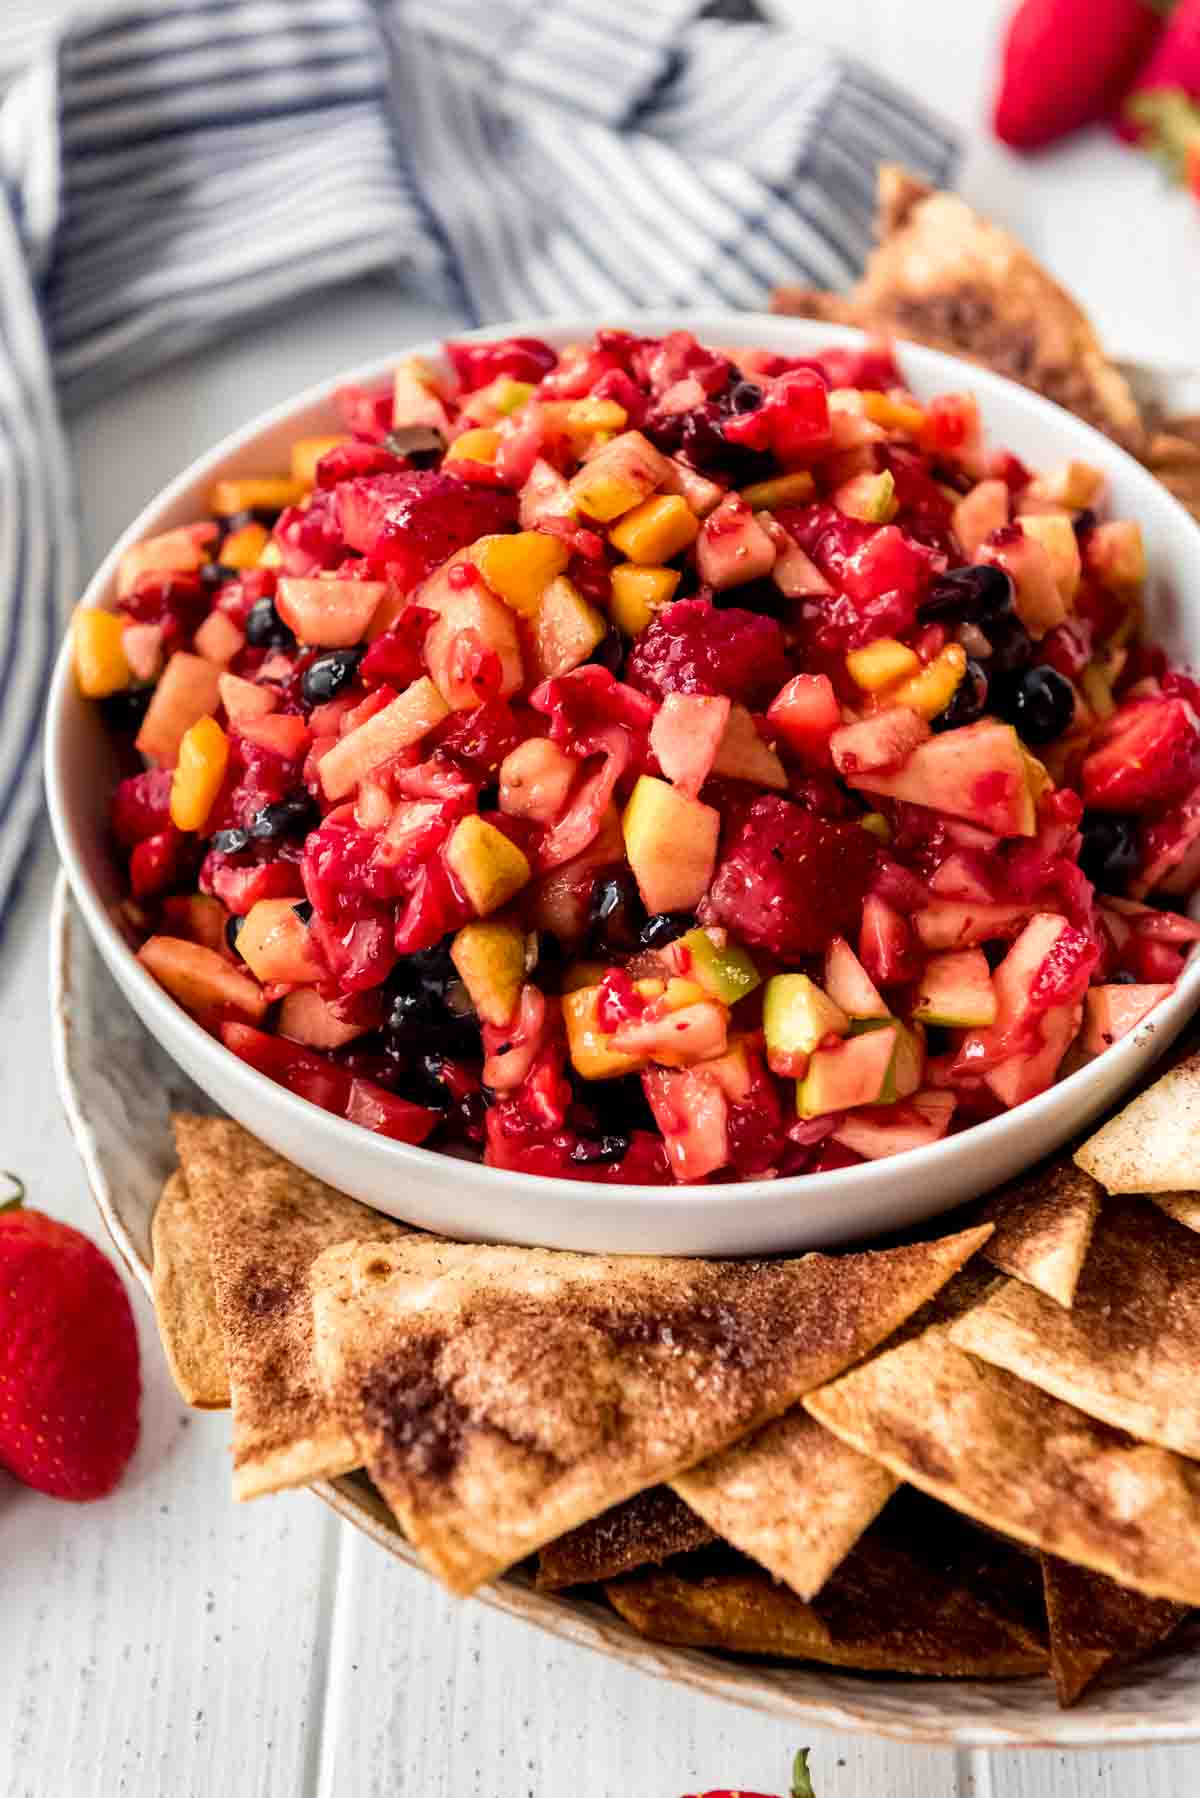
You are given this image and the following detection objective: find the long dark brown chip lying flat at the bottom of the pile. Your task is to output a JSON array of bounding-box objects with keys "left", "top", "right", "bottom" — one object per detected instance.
[{"left": 604, "top": 1507, "right": 1047, "bottom": 1679}]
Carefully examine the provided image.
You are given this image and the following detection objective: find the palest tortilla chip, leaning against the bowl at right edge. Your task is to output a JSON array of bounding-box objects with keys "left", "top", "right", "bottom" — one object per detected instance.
[{"left": 1076, "top": 1055, "right": 1200, "bottom": 1194}]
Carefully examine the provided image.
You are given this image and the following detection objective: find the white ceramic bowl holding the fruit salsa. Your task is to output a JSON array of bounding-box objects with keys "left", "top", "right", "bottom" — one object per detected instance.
[{"left": 45, "top": 313, "right": 1200, "bottom": 1255}]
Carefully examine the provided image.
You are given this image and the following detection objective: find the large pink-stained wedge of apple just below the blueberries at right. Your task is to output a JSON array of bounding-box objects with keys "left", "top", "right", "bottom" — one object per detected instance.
[{"left": 842, "top": 714, "right": 1036, "bottom": 836}]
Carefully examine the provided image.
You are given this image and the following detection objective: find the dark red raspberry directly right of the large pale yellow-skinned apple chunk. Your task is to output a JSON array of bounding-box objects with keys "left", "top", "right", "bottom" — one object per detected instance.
[{"left": 707, "top": 798, "right": 876, "bottom": 960}]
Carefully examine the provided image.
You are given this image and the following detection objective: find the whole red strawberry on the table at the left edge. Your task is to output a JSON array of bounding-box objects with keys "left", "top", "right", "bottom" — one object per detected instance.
[{"left": 0, "top": 1199, "right": 142, "bottom": 1501}]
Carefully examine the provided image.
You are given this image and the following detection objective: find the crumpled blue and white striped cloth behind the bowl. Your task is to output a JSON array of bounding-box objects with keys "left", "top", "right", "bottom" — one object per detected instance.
[{"left": 0, "top": 0, "right": 955, "bottom": 926}]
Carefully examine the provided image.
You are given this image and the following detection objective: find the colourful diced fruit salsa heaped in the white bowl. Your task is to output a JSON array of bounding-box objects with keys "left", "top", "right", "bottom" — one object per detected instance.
[{"left": 74, "top": 331, "right": 1200, "bottom": 1183}]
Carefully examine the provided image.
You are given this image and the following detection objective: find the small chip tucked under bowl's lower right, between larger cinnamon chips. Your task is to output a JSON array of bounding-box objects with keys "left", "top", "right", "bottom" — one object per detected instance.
[{"left": 979, "top": 1154, "right": 1103, "bottom": 1307}]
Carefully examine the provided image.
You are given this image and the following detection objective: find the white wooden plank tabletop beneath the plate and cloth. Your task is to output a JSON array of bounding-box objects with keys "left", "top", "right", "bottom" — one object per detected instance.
[{"left": 0, "top": 0, "right": 1200, "bottom": 1798}]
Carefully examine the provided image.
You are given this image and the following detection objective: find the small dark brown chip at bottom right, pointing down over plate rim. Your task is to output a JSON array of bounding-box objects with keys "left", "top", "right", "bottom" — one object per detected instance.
[{"left": 1042, "top": 1555, "right": 1187, "bottom": 1708}]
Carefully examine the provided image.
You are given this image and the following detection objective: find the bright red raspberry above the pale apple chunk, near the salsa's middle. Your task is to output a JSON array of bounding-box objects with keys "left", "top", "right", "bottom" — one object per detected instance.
[{"left": 624, "top": 599, "right": 792, "bottom": 710}]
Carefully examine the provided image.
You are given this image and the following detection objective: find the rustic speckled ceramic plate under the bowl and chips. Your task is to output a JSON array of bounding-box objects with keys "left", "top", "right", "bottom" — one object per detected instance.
[{"left": 50, "top": 876, "right": 1200, "bottom": 1748}]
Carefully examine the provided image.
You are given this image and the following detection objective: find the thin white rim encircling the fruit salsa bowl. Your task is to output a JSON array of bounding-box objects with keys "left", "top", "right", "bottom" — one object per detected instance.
[{"left": 43, "top": 307, "right": 1200, "bottom": 1212}]
